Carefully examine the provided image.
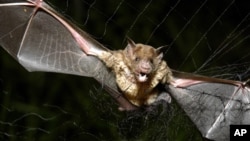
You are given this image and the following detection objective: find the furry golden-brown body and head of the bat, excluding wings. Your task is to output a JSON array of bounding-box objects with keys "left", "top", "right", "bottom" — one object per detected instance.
[{"left": 83, "top": 40, "right": 173, "bottom": 106}]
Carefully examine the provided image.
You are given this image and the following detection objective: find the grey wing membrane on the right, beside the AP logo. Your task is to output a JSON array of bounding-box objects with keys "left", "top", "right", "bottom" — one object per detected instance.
[{"left": 171, "top": 72, "right": 250, "bottom": 141}]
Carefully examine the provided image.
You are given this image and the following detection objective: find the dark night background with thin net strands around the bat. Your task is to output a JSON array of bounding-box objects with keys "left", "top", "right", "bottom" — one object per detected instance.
[{"left": 0, "top": 0, "right": 250, "bottom": 141}]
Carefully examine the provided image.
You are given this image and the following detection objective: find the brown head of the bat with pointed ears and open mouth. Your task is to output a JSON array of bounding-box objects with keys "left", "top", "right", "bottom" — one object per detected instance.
[{"left": 125, "top": 39, "right": 163, "bottom": 82}]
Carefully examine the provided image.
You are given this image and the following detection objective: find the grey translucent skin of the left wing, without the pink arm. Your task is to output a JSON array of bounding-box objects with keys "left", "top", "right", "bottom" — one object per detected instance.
[{"left": 0, "top": 0, "right": 105, "bottom": 77}]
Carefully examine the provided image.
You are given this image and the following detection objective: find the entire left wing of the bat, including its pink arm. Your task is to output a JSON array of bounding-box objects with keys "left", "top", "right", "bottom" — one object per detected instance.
[{"left": 0, "top": 0, "right": 136, "bottom": 109}]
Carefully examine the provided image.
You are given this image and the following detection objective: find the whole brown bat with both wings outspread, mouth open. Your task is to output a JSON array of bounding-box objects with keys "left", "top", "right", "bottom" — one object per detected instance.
[{"left": 0, "top": 0, "right": 250, "bottom": 140}]
